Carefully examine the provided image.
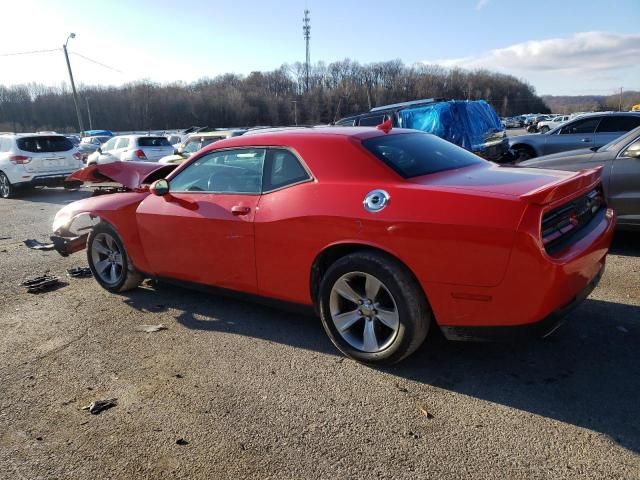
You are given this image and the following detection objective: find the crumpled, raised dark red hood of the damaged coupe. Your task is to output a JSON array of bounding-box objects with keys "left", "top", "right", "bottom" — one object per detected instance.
[{"left": 65, "top": 162, "right": 177, "bottom": 190}]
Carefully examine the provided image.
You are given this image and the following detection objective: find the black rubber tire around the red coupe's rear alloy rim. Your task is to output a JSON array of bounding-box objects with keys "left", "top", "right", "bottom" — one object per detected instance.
[{"left": 318, "top": 250, "right": 432, "bottom": 365}]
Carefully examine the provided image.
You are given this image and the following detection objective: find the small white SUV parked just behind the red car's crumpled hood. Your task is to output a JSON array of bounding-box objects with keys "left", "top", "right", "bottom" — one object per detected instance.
[{"left": 87, "top": 135, "right": 175, "bottom": 165}]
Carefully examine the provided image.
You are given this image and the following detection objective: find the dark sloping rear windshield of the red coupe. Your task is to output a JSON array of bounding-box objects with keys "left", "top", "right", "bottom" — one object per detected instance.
[{"left": 362, "top": 133, "right": 484, "bottom": 178}]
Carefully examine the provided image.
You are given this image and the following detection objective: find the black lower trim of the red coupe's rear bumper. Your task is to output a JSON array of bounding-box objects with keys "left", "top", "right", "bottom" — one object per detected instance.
[{"left": 440, "top": 266, "right": 604, "bottom": 342}]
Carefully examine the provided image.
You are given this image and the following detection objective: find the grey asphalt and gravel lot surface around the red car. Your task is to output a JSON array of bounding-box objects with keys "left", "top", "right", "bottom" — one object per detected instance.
[{"left": 0, "top": 189, "right": 640, "bottom": 479}]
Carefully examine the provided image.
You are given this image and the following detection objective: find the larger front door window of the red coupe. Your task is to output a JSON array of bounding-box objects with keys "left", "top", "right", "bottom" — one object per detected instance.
[{"left": 171, "top": 148, "right": 266, "bottom": 194}]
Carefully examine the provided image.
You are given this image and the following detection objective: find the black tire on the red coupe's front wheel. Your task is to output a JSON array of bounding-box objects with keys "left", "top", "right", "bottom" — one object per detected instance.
[{"left": 87, "top": 222, "right": 144, "bottom": 293}]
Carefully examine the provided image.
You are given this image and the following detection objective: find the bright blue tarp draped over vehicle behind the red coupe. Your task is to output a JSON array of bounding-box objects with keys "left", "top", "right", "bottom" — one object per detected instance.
[{"left": 398, "top": 100, "right": 504, "bottom": 153}]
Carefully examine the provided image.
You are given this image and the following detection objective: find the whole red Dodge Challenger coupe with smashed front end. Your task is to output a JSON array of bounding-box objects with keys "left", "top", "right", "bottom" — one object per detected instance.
[{"left": 52, "top": 126, "right": 615, "bottom": 364}]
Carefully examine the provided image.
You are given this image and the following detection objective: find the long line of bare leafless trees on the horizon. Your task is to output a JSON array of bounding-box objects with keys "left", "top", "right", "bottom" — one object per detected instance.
[{"left": 0, "top": 59, "right": 548, "bottom": 132}]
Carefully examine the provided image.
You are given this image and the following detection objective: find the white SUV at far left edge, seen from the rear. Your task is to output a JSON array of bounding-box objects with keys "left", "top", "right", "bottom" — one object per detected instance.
[{"left": 0, "top": 133, "right": 84, "bottom": 198}]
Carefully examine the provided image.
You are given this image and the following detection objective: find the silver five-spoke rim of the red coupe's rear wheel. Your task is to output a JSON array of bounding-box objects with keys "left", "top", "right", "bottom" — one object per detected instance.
[{"left": 329, "top": 272, "right": 400, "bottom": 353}]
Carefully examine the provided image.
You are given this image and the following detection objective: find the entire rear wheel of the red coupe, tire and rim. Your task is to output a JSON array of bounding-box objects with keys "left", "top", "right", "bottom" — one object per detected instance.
[{"left": 319, "top": 251, "right": 431, "bottom": 365}]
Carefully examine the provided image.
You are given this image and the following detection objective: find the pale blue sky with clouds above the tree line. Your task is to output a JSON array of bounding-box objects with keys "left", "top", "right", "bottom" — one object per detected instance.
[{"left": 0, "top": 0, "right": 640, "bottom": 95}]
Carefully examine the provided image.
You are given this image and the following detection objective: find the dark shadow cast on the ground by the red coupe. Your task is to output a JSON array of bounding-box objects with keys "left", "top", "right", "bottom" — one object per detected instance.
[{"left": 125, "top": 284, "right": 640, "bottom": 452}]
